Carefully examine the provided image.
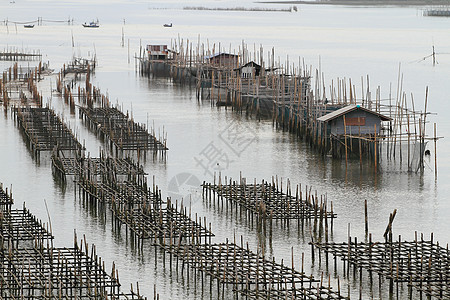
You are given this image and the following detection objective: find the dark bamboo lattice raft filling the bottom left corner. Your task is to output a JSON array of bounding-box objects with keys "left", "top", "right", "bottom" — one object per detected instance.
[{"left": 1, "top": 243, "right": 144, "bottom": 300}]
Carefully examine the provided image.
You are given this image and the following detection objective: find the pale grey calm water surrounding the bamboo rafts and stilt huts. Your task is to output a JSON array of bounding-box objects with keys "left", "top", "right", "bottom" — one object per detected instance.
[{"left": 0, "top": 0, "right": 450, "bottom": 299}]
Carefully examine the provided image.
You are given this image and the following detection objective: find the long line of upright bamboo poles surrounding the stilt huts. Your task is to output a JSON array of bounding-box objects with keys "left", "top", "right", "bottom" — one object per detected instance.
[{"left": 137, "top": 37, "right": 440, "bottom": 173}]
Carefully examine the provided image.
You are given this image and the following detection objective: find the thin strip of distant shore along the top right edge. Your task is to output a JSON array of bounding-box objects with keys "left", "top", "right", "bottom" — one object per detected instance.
[{"left": 256, "top": 0, "right": 450, "bottom": 8}]
